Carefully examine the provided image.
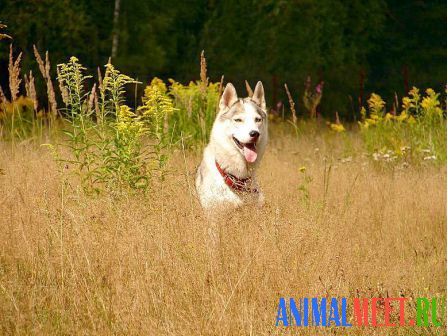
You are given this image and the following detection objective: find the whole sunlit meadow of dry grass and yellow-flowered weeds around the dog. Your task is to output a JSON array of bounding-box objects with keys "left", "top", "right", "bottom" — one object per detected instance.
[{"left": 0, "top": 44, "right": 447, "bottom": 335}]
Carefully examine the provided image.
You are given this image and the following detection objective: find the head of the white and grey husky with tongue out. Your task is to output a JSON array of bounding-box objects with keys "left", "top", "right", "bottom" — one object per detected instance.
[{"left": 214, "top": 82, "right": 267, "bottom": 163}]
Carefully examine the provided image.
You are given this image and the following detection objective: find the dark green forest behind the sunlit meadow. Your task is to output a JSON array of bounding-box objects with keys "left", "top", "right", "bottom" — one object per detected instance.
[{"left": 0, "top": 0, "right": 447, "bottom": 120}]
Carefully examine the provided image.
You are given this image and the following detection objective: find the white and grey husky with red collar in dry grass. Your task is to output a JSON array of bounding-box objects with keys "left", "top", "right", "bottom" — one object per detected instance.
[{"left": 196, "top": 82, "right": 268, "bottom": 214}]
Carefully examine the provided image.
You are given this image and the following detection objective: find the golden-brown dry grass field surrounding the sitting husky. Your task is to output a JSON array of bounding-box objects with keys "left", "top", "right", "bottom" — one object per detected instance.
[{"left": 0, "top": 130, "right": 447, "bottom": 335}]
